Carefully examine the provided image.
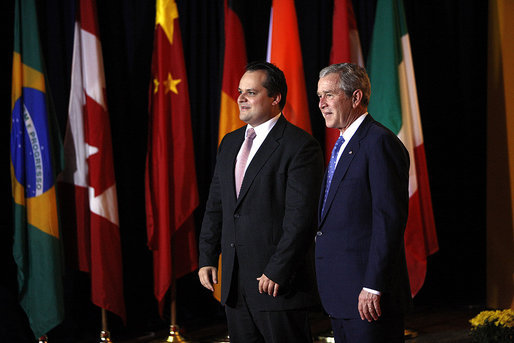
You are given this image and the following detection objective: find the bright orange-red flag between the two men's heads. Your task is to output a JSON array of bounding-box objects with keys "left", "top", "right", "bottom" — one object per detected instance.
[{"left": 267, "top": 0, "right": 311, "bottom": 133}]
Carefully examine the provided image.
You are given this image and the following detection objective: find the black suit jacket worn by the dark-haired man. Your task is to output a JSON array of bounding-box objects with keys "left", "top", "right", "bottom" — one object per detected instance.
[{"left": 199, "top": 116, "right": 323, "bottom": 311}]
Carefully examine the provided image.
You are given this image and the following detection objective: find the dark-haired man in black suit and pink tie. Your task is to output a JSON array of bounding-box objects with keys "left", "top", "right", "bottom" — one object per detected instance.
[{"left": 198, "top": 62, "right": 323, "bottom": 343}]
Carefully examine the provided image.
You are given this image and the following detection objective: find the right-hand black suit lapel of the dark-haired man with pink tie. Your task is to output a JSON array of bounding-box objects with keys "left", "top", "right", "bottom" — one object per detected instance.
[{"left": 234, "top": 115, "right": 287, "bottom": 207}]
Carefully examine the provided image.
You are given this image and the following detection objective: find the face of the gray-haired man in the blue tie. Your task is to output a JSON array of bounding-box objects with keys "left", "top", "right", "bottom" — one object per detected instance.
[{"left": 318, "top": 73, "right": 353, "bottom": 130}]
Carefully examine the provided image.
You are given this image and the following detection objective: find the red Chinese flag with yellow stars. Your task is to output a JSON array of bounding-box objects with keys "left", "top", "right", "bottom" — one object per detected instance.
[{"left": 145, "top": 0, "right": 199, "bottom": 313}]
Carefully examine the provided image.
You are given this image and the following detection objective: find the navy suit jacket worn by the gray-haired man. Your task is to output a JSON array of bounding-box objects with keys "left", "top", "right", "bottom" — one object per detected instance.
[{"left": 316, "top": 114, "right": 411, "bottom": 318}]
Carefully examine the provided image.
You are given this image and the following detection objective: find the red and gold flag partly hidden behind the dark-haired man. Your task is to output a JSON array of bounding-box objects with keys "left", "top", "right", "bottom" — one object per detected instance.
[{"left": 210, "top": 0, "right": 246, "bottom": 301}]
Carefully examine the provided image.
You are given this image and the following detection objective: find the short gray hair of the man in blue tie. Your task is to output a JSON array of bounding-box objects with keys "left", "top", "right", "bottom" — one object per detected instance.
[{"left": 319, "top": 63, "right": 371, "bottom": 106}]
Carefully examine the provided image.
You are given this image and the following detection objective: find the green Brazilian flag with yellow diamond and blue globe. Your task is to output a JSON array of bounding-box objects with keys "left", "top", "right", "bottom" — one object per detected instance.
[{"left": 11, "top": 0, "right": 64, "bottom": 338}]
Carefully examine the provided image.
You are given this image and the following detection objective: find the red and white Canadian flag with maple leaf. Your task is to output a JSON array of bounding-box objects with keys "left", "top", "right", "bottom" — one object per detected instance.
[{"left": 58, "top": 0, "right": 125, "bottom": 320}]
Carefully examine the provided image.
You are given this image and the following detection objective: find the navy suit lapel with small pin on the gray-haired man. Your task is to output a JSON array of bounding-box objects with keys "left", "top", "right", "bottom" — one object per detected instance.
[{"left": 319, "top": 114, "right": 373, "bottom": 226}]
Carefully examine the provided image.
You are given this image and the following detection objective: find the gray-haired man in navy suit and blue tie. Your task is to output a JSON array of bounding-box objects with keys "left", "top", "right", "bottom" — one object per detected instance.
[{"left": 316, "top": 63, "right": 411, "bottom": 343}]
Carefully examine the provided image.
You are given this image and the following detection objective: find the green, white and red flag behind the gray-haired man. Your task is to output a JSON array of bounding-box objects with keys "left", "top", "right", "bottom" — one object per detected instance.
[{"left": 368, "top": 0, "right": 439, "bottom": 297}]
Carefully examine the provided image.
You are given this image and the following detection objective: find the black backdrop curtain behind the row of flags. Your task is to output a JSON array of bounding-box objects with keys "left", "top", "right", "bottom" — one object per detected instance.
[{"left": 0, "top": 0, "right": 488, "bottom": 342}]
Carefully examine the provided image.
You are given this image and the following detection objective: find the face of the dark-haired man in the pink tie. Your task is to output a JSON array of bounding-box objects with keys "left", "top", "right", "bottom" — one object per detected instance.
[{"left": 237, "top": 70, "right": 279, "bottom": 127}]
